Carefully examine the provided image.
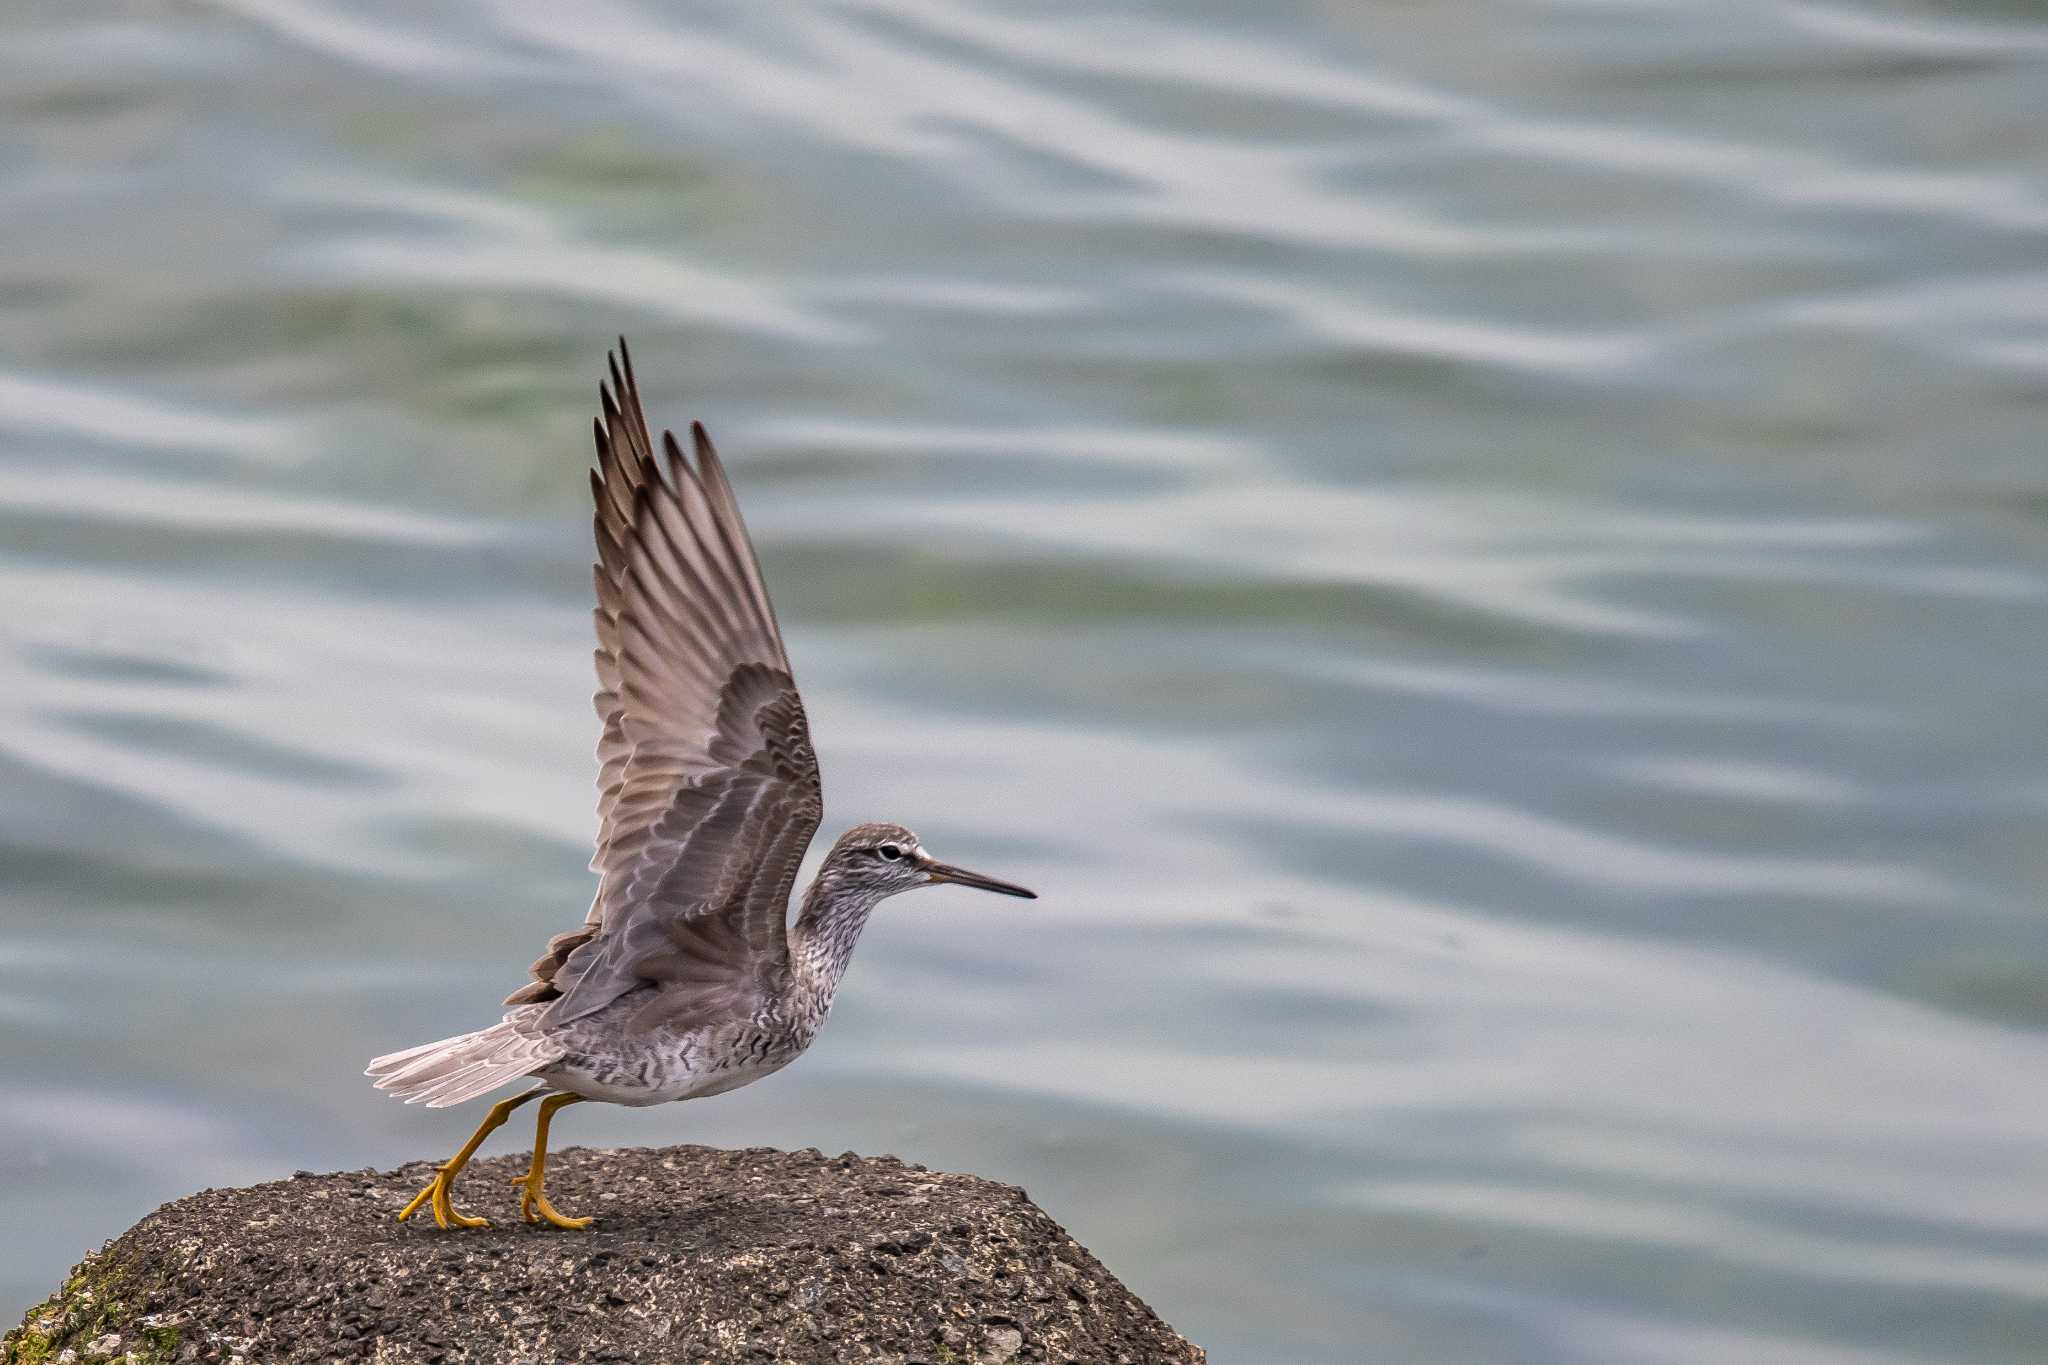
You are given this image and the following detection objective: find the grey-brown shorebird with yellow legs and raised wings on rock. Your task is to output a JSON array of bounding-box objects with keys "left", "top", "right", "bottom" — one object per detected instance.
[{"left": 365, "top": 338, "right": 1036, "bottom": 1230}]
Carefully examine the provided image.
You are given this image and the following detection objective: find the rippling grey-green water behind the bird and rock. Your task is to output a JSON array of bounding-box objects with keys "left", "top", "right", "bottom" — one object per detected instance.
[{"left": 0, "top": 0, "right": 2048, "bottom": 1365}]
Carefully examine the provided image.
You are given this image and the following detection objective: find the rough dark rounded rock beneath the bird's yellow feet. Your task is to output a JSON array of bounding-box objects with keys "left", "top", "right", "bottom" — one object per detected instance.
[{"left": 0, "top": 1146, "right": 1206, "bottom": 1365}]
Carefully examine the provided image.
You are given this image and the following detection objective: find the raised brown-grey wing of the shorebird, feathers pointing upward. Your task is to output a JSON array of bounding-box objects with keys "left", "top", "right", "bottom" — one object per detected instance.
[{"left": 506, "top": 340, "right": 823, "bottom": 1023}]
